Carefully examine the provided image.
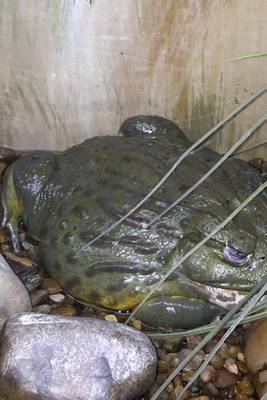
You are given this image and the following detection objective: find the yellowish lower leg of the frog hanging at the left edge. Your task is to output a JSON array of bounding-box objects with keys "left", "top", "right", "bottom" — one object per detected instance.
[{"left": 1, "top": 165, "right": 22, "bottom": 253}]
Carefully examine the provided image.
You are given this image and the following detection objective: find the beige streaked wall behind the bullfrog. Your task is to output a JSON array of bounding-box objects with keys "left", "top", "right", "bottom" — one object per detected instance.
[{"left": 0, "top": 0, "right": 267, "bottom": 158}]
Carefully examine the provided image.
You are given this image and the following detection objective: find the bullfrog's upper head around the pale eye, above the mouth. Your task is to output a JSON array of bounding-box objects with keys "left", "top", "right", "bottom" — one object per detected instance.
[{"left": 179, "top": 196, "right": 267, "bottom": 290}]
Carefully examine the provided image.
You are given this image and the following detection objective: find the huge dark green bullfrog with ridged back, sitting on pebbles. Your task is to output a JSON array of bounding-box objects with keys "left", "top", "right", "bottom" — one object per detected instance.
[{"left": 2, "top": 116, "right": 267, "bottom": 328}]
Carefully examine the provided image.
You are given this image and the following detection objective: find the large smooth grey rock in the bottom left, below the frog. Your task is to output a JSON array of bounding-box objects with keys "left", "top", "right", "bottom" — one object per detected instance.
[{"left": 0, "top": 313, "right": 157, "bottom": 400}]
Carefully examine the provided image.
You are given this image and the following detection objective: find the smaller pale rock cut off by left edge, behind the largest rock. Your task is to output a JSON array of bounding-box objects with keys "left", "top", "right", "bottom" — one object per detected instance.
[{"left": 0, "top": 254, "right": 31, "bottom": 330}]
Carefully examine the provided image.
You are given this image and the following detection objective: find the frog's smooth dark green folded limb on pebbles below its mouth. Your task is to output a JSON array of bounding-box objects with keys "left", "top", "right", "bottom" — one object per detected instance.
[{"left": 136, "top": 296, "right": 223, "bottom": 330}]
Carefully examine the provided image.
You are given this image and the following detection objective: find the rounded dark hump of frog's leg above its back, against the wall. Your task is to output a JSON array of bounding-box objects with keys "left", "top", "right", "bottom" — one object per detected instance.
[{"left": 119, "top": 115, "right": 186, "bottom": 141}]
